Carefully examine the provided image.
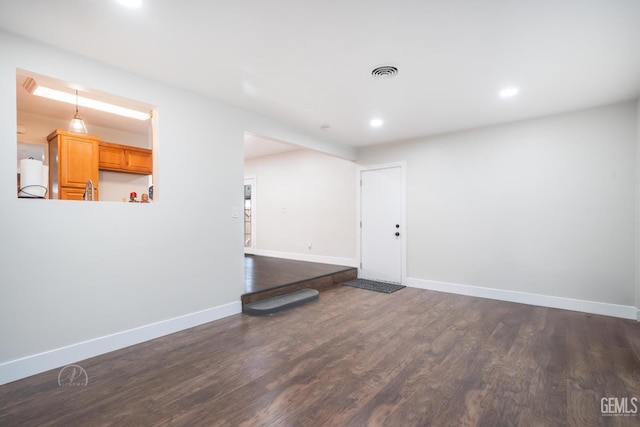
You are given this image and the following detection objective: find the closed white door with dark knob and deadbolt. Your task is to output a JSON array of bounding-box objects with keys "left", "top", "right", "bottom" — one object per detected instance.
[{"left": 360, "top": 166, "right": 404, "bottom": 283}]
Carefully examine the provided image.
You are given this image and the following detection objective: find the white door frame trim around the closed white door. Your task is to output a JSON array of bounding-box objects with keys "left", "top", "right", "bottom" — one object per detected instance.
[{"left": 356, "top": 160, "right": 408, "bottom": 285}]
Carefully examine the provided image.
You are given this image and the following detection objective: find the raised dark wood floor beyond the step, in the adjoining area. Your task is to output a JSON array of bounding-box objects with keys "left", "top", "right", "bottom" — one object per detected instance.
[{"left": 244, "top": 255, "right": 353, "bottom": 294}]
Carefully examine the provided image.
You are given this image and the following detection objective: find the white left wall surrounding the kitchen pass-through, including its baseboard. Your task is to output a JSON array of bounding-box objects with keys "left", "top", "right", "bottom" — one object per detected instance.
[{"left": 0, "top": 32, "right": 342, "bottom": 383}]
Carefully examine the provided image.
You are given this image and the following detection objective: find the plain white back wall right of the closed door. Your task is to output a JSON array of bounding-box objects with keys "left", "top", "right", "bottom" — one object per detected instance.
[{"left": 358, "top": 102, "right": 637, "bottom": 312}]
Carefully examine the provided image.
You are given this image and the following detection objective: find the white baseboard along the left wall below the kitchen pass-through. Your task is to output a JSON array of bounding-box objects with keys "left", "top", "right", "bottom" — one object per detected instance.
[{"left": 0, "top": 301, "right": 242, "bottom": 385}]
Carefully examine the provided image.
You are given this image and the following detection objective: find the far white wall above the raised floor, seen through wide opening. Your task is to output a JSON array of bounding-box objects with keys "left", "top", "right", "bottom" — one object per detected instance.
[{"left": 245, "top": 150, "right": 356, "bottom": 265}]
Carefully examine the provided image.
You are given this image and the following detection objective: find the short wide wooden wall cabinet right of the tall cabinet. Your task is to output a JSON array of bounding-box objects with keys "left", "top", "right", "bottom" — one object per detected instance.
[{"left": 99, "top": 142, "right": 153, "bottom": 175}]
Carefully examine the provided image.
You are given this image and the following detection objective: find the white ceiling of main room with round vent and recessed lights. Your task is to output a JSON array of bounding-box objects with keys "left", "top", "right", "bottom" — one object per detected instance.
[{"left": 0, "top": 0, "right": 640, "bottom": 150}]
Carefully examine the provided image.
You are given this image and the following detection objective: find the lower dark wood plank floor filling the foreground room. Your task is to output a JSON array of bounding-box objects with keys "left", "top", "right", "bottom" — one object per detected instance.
[{"left": 0, "top": 286, "right": 640, "bottom": 426}]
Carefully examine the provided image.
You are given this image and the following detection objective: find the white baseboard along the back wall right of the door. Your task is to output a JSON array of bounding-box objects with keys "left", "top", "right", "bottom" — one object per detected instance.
[{"left": 405, "top": 278, "right": 640, "bottom": 320}]
